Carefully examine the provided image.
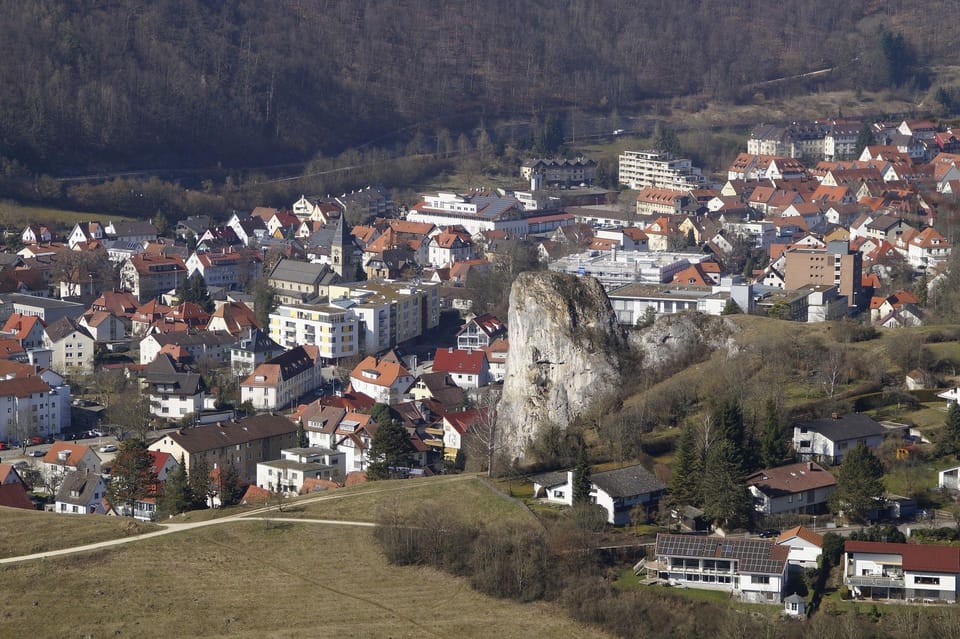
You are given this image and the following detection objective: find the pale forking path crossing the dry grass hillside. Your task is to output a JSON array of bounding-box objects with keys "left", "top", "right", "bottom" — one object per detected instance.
[{"left": 0, "top": 475, "right": 474, "bottom": 565}]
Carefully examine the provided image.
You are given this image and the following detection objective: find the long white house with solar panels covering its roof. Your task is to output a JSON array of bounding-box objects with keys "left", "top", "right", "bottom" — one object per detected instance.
[{"left": 646, "top": 533, "right": 790, "bottom": 603}]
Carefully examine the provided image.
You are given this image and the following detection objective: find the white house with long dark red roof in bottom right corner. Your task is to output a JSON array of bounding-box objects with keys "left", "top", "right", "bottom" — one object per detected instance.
[{"left": 842, "top": 541, "right": 960, "bottom": 603}]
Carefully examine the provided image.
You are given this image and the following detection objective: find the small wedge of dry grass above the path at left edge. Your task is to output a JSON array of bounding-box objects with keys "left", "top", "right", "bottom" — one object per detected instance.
[{"left": 0, "top": 507, "right": 158, "bottom": 557}]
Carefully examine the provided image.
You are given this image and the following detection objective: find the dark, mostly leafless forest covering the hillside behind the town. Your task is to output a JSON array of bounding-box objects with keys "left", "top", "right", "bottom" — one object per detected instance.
[{"left": 0, "top": 0, "right": 960, "bottom": 175}]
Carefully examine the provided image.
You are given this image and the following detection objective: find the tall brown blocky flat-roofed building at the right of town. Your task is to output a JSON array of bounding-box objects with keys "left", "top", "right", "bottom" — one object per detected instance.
[{"left": 784, "top": 241, "right": 867, "bottom": 307}]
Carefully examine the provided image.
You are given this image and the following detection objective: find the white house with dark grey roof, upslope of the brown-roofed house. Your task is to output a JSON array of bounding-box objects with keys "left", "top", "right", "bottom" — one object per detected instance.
[{"left": 793, "top": 413, "right": 887, "bottom": 464}]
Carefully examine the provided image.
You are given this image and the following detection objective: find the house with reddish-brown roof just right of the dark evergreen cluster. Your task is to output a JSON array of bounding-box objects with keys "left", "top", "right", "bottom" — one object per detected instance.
[{"left": 746, "top": 462, "right": 837, "bottom": 515}]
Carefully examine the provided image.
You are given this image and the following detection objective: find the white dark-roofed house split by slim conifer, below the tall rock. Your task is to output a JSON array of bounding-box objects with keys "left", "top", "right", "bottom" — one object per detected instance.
[{"left": 533, "top": 464, "right": 667, "bottom": 526}]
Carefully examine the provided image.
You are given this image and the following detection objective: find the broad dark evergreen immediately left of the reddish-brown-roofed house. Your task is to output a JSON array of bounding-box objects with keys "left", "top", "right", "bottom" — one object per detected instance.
[{"left": 703, "top": 439, "right": 753, "bottom": 528}]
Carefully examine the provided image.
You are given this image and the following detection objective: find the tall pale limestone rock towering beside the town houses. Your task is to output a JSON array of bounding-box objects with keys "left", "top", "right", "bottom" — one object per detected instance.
[{"left": 498, "top": 272, "right": 628, "bottom": 458}]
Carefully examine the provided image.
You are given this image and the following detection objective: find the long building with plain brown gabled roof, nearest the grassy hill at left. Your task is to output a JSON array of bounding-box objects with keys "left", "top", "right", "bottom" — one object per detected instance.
[{"left": 150, "top": 414, "right": 297, "bottom": 483}]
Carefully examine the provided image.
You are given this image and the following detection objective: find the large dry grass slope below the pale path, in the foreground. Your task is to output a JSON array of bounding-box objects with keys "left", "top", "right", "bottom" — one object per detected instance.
[{"left": 0, "top": 522, "right": 603, "bottom": 639}]
